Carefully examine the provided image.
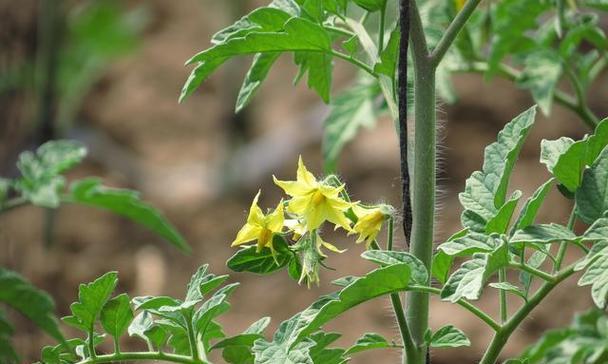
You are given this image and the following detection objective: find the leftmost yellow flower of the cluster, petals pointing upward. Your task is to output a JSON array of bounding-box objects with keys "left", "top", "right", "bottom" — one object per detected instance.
[{"left": 231, "top": 191, "right": 285, "bottom": 254}]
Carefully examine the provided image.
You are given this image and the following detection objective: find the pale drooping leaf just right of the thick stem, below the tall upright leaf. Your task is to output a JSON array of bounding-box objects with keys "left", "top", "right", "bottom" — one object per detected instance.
[{"left": 441, "top": 244, "right": 509, "bottom": 302}]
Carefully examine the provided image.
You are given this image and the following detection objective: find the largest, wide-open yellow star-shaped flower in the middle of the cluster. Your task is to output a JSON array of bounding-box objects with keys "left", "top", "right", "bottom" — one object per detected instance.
[{"left": 273, "top": 157, "right": 352, "bottom": 231}]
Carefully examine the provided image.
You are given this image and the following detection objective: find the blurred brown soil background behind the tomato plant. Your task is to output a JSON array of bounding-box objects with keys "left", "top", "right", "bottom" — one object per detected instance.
[{"left": 0, "top": 0, "right": 608, "bottom": 363}]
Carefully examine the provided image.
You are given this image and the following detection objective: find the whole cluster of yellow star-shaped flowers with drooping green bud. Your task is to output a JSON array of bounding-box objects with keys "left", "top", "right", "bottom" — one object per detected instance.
[{"left": 232, "top": 157, "right": 393, "bottom": 285}]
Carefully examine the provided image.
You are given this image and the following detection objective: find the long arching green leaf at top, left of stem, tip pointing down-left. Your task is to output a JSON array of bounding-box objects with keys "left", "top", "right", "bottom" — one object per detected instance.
[{"left": 180, "top": 18, "right": 332, "bottom": 102}]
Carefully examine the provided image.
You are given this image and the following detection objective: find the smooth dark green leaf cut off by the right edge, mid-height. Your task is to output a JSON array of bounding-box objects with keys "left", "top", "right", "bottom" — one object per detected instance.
[{"left": 575, "top": 147, "right": 608, "bottom": 224}]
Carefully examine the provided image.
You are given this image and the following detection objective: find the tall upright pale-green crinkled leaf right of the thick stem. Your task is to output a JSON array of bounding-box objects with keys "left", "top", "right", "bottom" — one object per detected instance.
[{"left": 459, "top": 107, "right": 536, "bottom": 230}]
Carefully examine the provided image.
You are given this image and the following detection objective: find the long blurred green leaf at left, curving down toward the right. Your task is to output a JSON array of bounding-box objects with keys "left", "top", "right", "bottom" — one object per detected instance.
[{"left": 67, "top": 178, "right": 190, "bottom": 252}]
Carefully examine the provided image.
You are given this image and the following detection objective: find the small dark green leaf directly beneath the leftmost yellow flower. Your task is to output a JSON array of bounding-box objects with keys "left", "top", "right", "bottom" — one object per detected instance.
[{"left": 226, "top": 235, "right": 294, "bottom": 274}]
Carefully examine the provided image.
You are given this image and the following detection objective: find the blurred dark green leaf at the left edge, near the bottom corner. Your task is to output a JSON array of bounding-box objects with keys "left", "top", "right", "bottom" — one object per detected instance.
[{"left": 0, "top": 268, "right": 65, "bottom": 342}]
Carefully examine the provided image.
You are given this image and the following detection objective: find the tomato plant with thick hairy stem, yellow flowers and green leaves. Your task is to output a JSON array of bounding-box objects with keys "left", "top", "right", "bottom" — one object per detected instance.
[{"left": 2, "top": 0, "right": 608, "bottom": 364}]
